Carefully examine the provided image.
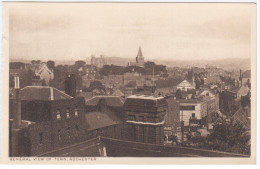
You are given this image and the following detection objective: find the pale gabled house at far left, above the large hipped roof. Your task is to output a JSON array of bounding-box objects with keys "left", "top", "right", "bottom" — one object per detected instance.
[{"left": 35, "top": 63, "right": 54, "bottom": 85}]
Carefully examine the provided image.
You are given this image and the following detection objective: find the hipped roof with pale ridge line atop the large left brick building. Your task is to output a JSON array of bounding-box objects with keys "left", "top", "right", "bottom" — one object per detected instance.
[{"left": 20, "top": 86, "right": 73, "bottom": 100}]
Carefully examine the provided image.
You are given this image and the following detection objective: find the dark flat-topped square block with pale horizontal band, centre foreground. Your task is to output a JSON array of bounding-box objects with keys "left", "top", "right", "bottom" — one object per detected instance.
[{"left": 124, "top": 95, "right": 168, "bottom": 144}]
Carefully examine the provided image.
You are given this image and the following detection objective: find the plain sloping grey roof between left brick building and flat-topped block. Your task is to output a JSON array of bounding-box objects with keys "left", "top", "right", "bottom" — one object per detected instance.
[{"left": 85, "top": 112, "right": 119, "bottom": 130}]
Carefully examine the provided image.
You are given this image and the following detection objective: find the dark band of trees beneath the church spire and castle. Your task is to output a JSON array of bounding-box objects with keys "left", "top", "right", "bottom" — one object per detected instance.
[{"left": 99, "top": 62, "right": 167, "bottom": 76}]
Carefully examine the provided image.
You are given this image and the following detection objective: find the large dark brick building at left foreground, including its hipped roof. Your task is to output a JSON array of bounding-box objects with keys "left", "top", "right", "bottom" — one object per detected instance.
[{"left": 9, "top": 86, "right": 86, "bottom": 156}]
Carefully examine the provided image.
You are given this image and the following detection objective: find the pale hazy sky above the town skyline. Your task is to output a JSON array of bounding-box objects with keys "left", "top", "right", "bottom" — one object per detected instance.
[{"left": 9, "top": 3, "right": 254, "bottom": 60}]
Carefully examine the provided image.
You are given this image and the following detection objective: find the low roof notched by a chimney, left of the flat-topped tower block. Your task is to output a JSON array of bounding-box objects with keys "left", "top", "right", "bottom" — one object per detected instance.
[{"left": 86, "top": 96, "right": 124, "bottom": 107}]
